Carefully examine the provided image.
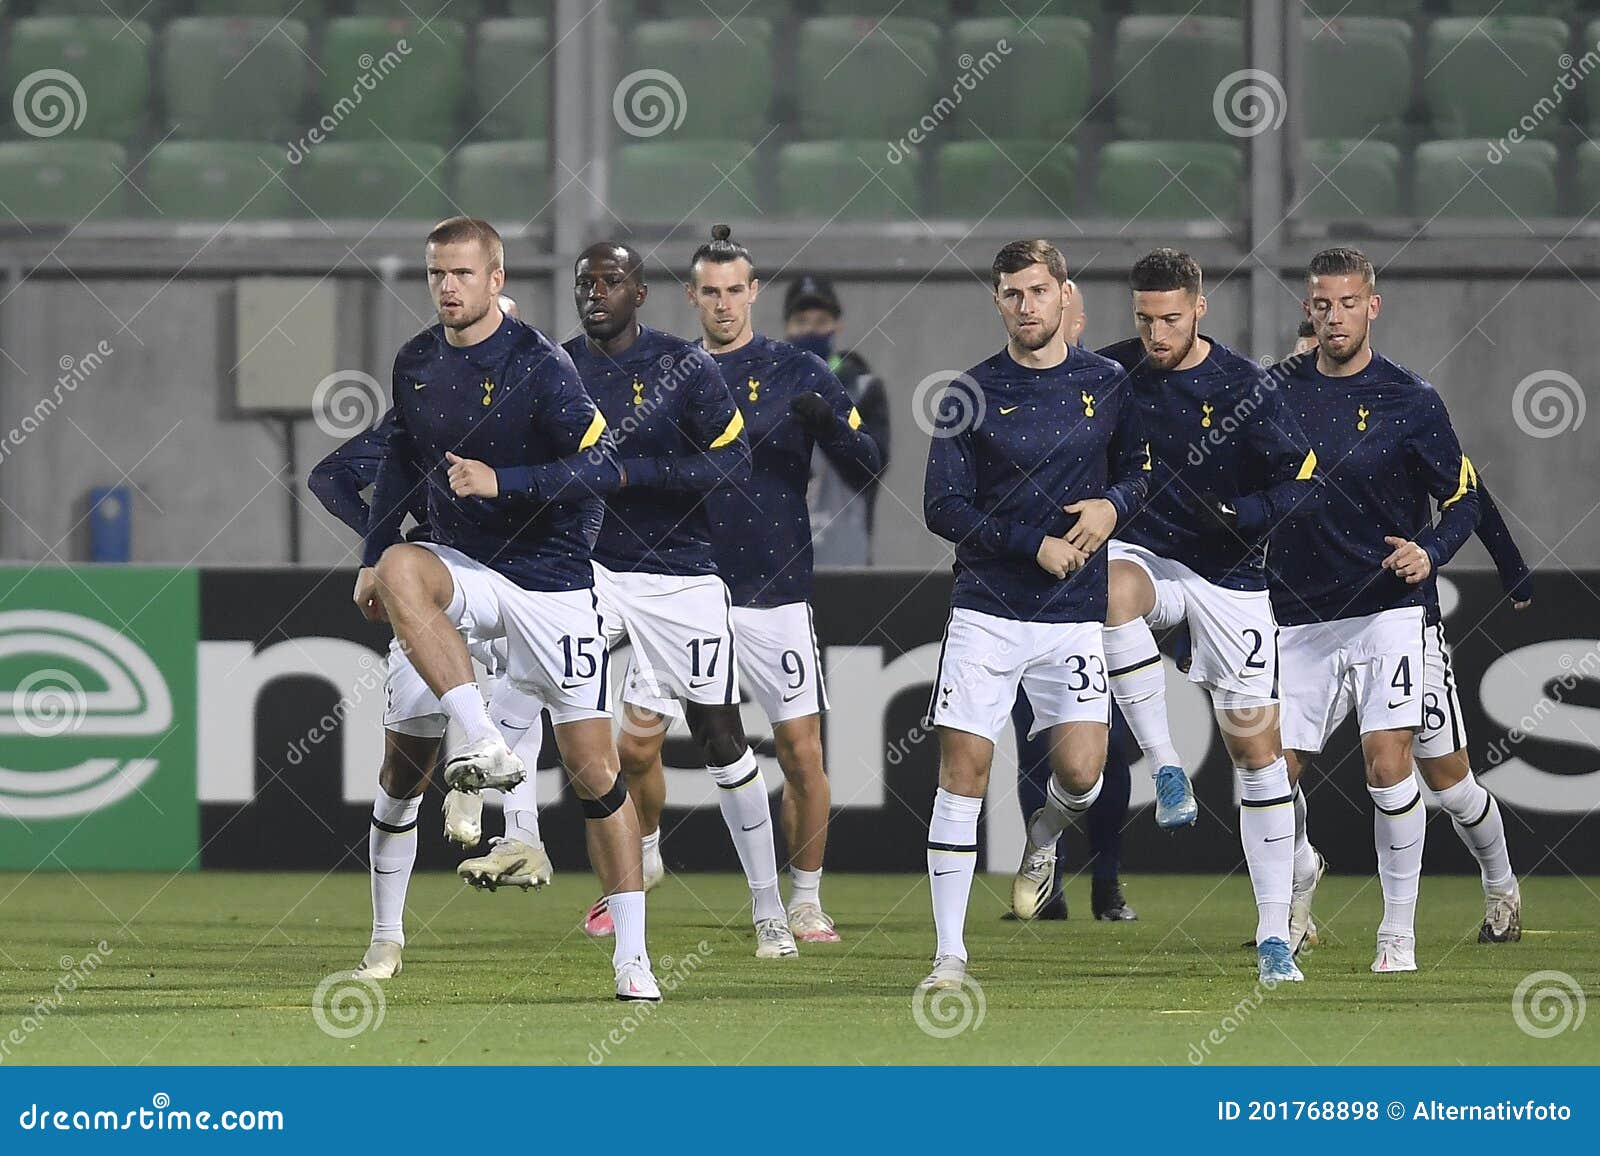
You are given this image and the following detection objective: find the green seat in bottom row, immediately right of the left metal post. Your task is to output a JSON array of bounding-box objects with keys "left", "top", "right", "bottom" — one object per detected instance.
[{"left": 610, "top": 141, "right": 765, "bottom": 223}]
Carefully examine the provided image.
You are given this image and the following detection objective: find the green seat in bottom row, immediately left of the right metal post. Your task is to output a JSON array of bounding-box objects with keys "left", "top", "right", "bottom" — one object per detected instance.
[{"left": 1098, "top": 141, "right": 1245, "bottom": 221}]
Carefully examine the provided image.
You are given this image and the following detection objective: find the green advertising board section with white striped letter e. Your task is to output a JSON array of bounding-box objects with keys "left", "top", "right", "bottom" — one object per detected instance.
[{"left": 0, "top": 567, "right": 200, "bottom": 871}]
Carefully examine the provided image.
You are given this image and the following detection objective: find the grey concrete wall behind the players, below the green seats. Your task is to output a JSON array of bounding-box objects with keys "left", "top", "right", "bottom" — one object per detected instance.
[{"left": 0, "top": 271, "right": 1600, "bottom": 567}]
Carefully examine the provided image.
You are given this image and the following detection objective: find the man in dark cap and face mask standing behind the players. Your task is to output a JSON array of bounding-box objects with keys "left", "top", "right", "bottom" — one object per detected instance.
[{"left": 784, "top": 274, "right": 890, "bottom": 567}]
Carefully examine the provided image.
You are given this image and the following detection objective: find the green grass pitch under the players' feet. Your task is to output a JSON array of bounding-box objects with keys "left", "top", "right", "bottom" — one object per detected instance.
[{"left": 0, "top": 871, "right": 1600, "bottom": 1066}]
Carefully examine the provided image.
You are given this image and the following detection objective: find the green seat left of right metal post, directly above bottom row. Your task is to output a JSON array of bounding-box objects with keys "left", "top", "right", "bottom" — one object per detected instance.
[{"left": 1112, "top": 16, "right": 1245, "bottom": 141}]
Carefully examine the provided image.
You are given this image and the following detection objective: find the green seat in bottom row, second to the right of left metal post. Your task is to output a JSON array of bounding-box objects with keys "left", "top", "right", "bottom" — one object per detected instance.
[{"left": 778, "top": 141, "right": 920, "bottom": 221}]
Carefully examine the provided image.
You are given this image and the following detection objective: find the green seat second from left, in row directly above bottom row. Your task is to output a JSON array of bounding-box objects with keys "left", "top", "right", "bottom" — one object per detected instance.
[{"left": 162, "top": 16, "right": 309, "bottom": 141}]
